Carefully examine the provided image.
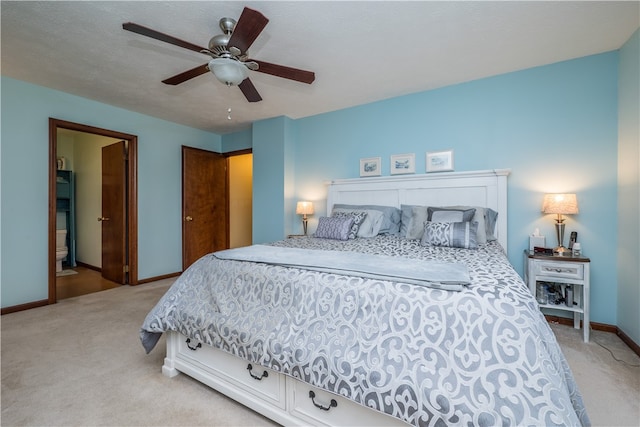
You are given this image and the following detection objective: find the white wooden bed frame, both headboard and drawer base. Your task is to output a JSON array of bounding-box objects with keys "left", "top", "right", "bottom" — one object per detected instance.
[{"left": 162, "top": 169, "right": 510, "bottom": 426}]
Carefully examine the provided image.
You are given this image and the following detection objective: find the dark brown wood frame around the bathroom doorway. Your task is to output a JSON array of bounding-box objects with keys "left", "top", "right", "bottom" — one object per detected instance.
[{"left": 48, "top": 117, "right": 139, "bottom": 304}]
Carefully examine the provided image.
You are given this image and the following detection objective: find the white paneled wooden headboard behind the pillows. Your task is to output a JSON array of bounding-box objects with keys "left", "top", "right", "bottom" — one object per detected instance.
[{"left": 327, "top": 169, "right": 511, "bottom": 251}]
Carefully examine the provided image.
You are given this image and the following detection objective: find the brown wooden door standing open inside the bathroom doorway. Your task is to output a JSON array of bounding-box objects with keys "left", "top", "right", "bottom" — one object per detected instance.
[{"left": 98, "top": 141, "right": 127, "bottom": 284}]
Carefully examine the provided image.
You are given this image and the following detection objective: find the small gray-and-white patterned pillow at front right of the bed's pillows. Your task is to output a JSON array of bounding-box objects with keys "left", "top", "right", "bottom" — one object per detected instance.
[{"left": 420, "top": 221, "right": 478, "bottom": 249}]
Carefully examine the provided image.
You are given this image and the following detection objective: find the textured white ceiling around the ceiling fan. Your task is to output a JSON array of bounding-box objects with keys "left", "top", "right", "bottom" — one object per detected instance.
[{"left": 0, "top": 1, "right": 640, "bottom": 134}]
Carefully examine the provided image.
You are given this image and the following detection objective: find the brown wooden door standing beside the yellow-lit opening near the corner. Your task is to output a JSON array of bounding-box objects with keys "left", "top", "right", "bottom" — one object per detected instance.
[{"left": 182, "top": 146, "right": 229, "bottom": 270}]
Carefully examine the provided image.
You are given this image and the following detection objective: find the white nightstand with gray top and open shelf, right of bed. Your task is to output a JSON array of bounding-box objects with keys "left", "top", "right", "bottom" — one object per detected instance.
[{"left": 524, "top": 250, "right": 591, "bottom": 342}]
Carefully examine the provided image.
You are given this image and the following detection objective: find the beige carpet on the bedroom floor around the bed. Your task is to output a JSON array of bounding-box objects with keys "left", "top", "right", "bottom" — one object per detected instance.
[{"left": 0, "top": 279, "right": 640, "bottom": 426}]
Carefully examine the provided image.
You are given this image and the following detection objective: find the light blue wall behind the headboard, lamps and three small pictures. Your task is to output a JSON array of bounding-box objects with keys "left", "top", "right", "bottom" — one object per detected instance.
[{"left": 288, "top": 52, "right": 618, "bottom": 324}]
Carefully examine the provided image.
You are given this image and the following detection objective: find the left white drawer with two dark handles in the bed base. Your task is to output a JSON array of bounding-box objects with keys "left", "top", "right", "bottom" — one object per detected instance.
[{"left": 178, "top": 335, "right": 286, "bottom": 409}]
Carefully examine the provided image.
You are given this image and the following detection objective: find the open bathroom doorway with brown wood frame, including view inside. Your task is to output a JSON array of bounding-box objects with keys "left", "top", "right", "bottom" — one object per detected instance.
[{"left": 48, "top": 119, "right": 138, "bottom": 304}]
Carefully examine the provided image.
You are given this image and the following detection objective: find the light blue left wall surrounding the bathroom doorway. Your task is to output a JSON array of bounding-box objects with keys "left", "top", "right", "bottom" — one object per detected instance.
[{"left": 0, "top": 77, "right": 221, "bottom": 307}]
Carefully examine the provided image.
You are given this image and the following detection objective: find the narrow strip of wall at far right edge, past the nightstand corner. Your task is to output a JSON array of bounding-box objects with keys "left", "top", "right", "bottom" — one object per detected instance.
[{"left": 617, "top": 30, "right": 640, "bottom": 343}]
